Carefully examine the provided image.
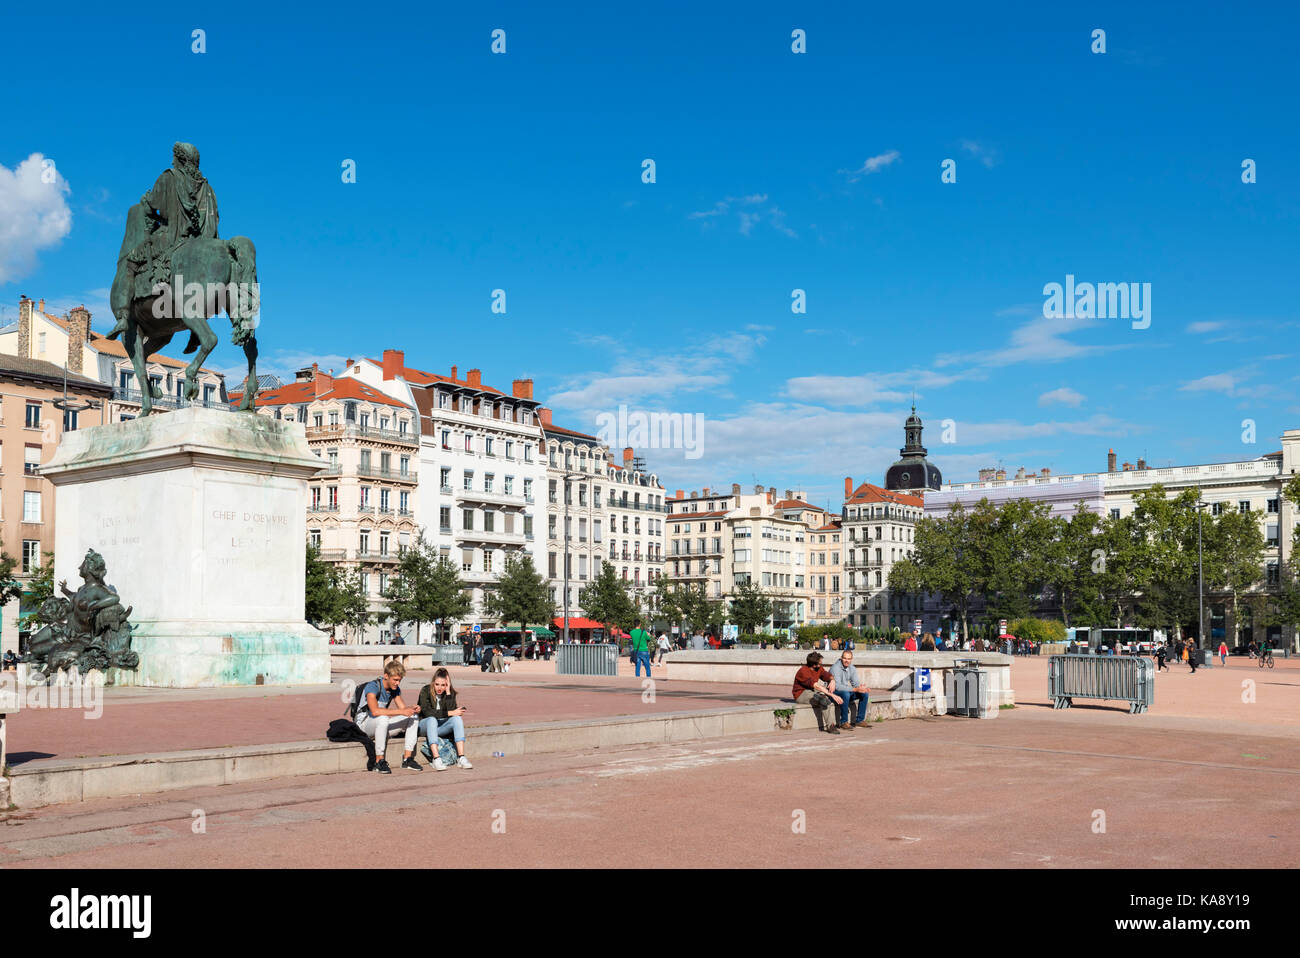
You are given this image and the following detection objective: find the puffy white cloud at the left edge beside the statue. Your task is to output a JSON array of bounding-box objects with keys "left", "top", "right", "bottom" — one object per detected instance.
[{"left": 0, "top": 153, "right": 73, "bottom": 285}]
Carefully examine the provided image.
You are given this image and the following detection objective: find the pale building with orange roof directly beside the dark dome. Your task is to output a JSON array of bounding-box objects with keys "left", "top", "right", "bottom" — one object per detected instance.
[{"left": 841, "top": 476, "right": 930, "bottom": 629}]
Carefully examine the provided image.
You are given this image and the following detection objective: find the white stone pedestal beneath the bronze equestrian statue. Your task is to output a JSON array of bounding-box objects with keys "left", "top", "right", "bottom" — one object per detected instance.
[{"left": 40, "top": 408, "right": 330, "bottom": 688}]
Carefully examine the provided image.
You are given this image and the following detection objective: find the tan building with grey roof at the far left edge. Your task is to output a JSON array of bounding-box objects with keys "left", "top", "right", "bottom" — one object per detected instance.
[{"left": 0, "top": 354, "right": 113, "bottom": 651}]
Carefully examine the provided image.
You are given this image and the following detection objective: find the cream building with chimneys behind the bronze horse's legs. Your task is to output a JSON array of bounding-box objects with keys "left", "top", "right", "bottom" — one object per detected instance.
[{"left": 0, "top": 296, "right": 227, "bottom": 422}]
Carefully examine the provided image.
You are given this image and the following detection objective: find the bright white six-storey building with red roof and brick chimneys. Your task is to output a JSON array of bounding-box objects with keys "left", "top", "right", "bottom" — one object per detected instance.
[{"left": 339, "top": 350, "right": 546, "bottom": 630}]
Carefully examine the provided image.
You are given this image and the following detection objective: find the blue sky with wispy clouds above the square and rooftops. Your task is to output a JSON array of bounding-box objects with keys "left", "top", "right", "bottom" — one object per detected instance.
[{"left": 0, "top": 3, "right": 1300, "bottom": 508}]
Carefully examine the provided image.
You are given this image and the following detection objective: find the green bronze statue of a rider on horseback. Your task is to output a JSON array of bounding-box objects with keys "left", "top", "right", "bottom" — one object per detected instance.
[{"left": 108, "top": 143, "right": 260, "bottom": 416}]
